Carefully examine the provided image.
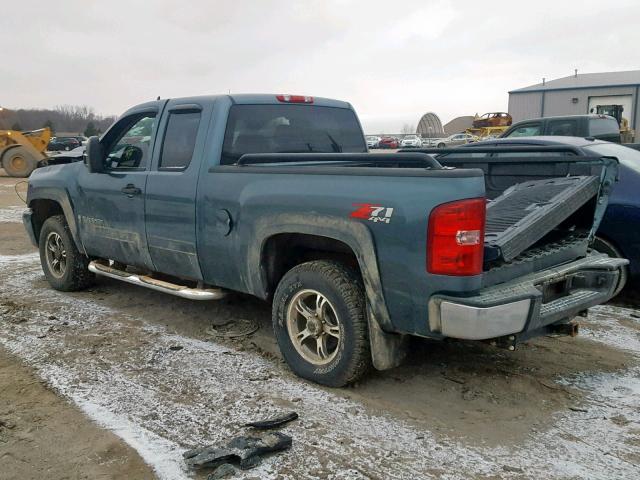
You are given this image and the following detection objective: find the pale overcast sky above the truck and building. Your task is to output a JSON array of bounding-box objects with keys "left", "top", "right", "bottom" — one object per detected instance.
[{"left": 0, "top": 0, "right": 640, "bottom": 132}]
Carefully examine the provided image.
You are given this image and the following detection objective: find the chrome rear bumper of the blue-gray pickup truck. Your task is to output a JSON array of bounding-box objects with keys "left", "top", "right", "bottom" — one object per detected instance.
[{"left": 429, "top": 254, "right": 629, "bottom": 340}]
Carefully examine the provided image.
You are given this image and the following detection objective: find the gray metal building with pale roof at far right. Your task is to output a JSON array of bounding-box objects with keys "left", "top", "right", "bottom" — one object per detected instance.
[{"left": 509, "top": 70, "right": 640, "bottom": 131}]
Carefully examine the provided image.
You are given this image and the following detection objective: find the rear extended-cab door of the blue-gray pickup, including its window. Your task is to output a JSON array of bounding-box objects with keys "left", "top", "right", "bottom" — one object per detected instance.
[{"left": 145, "top": 99, "right": 213, "bottom": 280}]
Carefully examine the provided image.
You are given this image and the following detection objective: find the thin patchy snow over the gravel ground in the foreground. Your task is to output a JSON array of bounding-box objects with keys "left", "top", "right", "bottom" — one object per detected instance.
[{"left": 0, "top": 254, "right": 640, "bottom": 479}]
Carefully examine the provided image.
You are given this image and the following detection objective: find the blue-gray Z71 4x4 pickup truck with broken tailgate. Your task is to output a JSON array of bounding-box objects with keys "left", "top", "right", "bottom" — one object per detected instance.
[{"left": 24, "top": 95, "right": 626, "bottom": 386}]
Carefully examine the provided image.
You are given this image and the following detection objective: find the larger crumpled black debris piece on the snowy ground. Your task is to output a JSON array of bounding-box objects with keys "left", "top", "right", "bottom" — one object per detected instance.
[{"left": 182, "top": 432, "right": 292, "bottom": 470}]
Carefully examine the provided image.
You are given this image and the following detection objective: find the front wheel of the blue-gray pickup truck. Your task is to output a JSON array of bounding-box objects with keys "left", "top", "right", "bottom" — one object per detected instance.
[{"left": 39, "top": 215, "right": 95, "bottom": 292}]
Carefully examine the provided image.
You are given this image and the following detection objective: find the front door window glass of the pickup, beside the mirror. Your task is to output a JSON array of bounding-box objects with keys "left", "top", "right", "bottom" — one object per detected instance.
[{"left": 106, "top": 113, "right": 156, "bottom": 170}]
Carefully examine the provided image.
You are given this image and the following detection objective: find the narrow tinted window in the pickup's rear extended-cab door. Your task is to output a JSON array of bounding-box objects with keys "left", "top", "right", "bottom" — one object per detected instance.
[{"left": 158, "top": 112, "right": 200, "bottom": 170}]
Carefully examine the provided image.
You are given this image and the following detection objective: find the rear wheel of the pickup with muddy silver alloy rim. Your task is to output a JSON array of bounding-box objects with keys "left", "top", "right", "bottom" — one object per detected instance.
[{"left": 273, "top": 260, "right": 371, "bottom": 387}]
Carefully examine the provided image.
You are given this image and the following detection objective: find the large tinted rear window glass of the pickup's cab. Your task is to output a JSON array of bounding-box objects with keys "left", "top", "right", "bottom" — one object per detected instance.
[{"left": 221, "top": 105, "right": 367, "bottom": 165}]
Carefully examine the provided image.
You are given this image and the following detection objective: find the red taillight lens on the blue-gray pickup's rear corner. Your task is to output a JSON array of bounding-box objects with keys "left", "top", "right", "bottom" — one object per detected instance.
[{"left": 427, "top": 198, "right": 486, "bottom": 275}]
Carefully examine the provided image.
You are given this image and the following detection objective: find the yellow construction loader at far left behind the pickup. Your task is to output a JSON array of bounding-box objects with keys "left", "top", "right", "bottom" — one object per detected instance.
[{"left": 0, "top": 128, "right": 51, "bottom": 177}]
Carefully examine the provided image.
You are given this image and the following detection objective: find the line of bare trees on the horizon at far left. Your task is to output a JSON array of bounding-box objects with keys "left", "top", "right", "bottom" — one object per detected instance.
[{"left": 0, "top": 105, "right": 116, "bottom": 136}]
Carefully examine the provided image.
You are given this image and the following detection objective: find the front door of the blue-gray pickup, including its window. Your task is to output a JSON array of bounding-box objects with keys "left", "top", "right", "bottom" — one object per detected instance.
[{"left": 76, "top": 109, "right": 158, "bottom": 269}]
